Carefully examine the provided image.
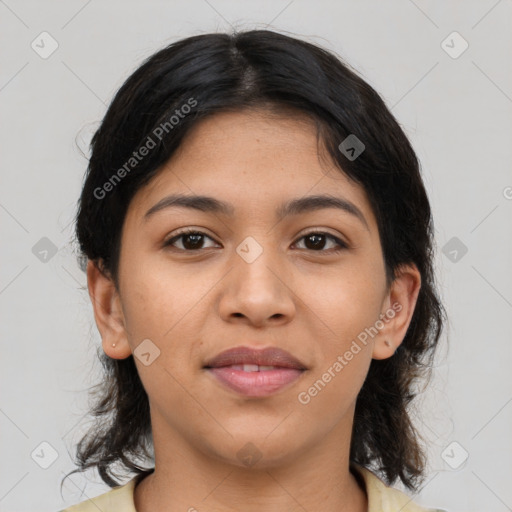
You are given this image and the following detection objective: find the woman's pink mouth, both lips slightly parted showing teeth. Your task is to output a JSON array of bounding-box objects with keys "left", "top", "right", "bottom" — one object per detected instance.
[{"left": 204, "top": 347, "right": 307, "bottom": 397}]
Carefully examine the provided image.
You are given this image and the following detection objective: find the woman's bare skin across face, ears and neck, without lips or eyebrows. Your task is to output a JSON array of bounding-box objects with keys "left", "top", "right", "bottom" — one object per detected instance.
[{"left": 87, "top": 111, "right": 421, "bottom": 512}]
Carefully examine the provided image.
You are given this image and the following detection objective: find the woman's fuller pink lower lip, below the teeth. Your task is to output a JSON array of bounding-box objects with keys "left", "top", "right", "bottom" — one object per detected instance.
[{"left": 208, "top": 367, "right": 303, "bottom": 397}]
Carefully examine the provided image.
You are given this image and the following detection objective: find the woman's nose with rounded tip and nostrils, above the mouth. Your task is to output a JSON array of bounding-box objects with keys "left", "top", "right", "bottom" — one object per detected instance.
[{"left": 219, "top": 245, "right": 296, "bottom": 327}]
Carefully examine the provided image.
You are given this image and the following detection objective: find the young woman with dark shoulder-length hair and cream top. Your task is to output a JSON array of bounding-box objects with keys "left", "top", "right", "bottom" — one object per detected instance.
[{"left": 60, "top": 30, "right": 445, "bottom": 512}]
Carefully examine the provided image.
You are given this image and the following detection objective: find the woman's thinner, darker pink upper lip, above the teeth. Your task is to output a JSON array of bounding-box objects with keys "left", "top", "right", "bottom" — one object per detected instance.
[{"left": 204, "top": 346, "right": 306, "bottom": 370}]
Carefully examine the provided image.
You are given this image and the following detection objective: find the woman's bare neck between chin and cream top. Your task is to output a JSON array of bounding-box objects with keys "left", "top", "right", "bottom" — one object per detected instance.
[{"left": 134, "top": 418, "right": 368, "bottom": 512}]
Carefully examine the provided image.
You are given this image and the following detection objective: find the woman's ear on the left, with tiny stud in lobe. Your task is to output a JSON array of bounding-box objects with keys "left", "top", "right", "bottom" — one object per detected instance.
[{"left": 87, "top": 260, "right": 131, "bottom": 359}]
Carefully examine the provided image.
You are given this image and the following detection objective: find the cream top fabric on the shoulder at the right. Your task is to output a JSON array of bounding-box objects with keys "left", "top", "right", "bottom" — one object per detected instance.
[{"left": 350, "top": 463, "right": 446, "bottom": 512}]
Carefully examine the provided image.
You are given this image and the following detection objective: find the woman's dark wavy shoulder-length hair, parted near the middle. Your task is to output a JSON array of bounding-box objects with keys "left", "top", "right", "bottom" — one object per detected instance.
[{"left": 68, "top": 30, "right": 445, "bottom": 489}]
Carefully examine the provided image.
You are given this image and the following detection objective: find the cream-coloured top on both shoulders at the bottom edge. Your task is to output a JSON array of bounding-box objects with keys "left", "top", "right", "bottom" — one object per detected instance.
[{"left": 59, "top": 463, "right": 446, "bottom": 512}]
